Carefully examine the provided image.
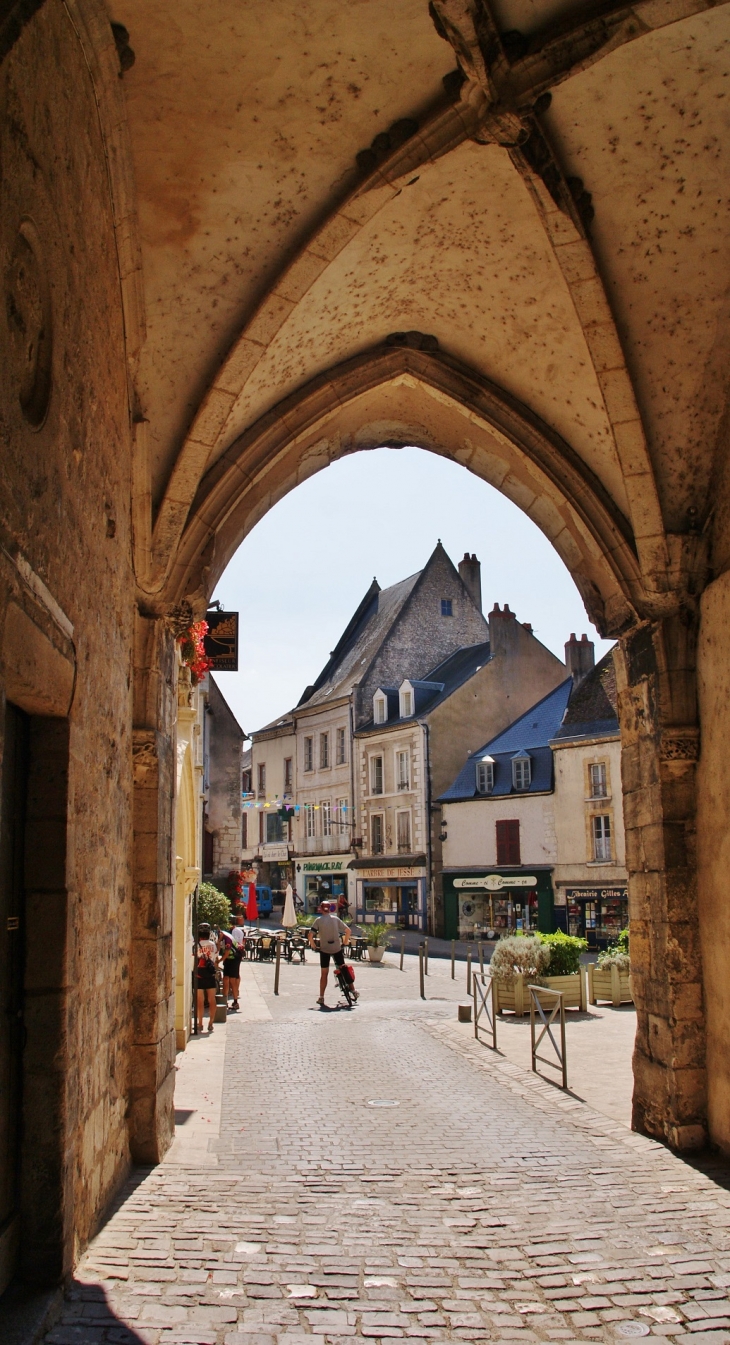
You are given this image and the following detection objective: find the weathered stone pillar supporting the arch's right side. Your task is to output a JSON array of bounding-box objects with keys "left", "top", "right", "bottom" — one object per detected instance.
[{"left": 614, "top": 612, "right": 706, "bottom": 1150}]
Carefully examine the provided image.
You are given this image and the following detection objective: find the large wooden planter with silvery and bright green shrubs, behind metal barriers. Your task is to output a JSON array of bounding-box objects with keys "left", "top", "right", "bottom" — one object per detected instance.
[{"left": 489, "top": 931, "right": 587, "bottom": 1014}]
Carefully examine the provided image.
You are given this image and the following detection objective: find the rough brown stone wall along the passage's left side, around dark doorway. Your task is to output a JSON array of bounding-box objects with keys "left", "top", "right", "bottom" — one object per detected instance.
[{"left": 0, "top": 4, "right": 133, "bottom": 1280}]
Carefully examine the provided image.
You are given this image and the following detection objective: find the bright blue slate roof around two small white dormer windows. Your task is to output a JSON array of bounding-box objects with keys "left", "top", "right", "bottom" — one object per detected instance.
[{"left": 440, "top": 678, "right": 573, "bottom": 803}]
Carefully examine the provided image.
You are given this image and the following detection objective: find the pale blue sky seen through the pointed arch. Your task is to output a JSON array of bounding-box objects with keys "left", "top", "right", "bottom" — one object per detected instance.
[{"left": 214, "top": 448, "right": 613, "bottom": 733}]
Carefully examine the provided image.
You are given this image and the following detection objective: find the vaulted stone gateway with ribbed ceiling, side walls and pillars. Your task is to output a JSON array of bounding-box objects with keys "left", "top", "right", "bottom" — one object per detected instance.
[{"left": 0, "top": 0, "right": 730, "bottom": 1284}]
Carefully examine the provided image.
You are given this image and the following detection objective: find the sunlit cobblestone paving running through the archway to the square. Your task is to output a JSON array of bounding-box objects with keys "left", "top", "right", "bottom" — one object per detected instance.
[{"left": 46, "top": 963, "right": 730, "bottom": 1345}]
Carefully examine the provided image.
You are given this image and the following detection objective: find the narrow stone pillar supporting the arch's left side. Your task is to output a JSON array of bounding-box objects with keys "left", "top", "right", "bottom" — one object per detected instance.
[{"left": 129, "top": 615, "right": 177, "bottom": 1163}]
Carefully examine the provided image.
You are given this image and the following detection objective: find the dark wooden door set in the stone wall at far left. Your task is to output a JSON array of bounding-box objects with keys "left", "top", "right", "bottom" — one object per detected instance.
[{"left": 0, "top": 705, "right": 30, "bottom": 1294}]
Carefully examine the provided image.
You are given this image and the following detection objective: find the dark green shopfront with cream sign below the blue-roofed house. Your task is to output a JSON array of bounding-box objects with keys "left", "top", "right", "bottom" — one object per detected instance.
[{"left": 444, "top": 869, "right": 555, "bottom": 939}]
